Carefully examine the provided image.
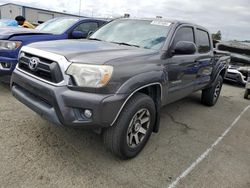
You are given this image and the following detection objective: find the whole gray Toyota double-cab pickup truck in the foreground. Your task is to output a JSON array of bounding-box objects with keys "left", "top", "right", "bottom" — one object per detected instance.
[{"left": 11, "top": 19, "right": 230, "bottom": 159}]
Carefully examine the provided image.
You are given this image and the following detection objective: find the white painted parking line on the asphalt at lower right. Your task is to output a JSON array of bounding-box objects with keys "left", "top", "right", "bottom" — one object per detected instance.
[{"left": 168, "top": 105, "right": 250, "bottom": 188}]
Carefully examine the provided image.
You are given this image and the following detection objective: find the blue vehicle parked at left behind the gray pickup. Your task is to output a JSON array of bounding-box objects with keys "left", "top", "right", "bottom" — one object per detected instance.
[{"left": 0, "top": 17, "right": 106, "bottom": 82}]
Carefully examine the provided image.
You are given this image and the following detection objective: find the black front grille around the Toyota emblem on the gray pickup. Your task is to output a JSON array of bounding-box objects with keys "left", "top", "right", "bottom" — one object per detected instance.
[{"left": 18, "top": 53, "right": 63, "bottom": 83}]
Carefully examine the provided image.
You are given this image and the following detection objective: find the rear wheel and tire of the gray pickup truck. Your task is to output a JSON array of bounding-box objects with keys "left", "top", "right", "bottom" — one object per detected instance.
[{"left": 201, "top": 75, "right": 223, "bottom": 106}]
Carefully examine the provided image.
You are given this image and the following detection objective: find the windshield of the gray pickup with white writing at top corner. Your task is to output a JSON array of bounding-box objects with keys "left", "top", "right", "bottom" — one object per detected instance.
[{"left": 89, "top": 19, "right": 171, "bottom": 50}]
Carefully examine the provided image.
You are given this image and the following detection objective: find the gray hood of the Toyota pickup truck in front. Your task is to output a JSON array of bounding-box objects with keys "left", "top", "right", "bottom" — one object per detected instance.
[{"left": 28, "top": 40, "right": 157, "bottom": 64}]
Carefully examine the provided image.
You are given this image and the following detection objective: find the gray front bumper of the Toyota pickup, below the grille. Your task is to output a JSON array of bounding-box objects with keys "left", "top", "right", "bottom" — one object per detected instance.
[{"left": 11, "top": 69, "right": 126, "bottom": 128}]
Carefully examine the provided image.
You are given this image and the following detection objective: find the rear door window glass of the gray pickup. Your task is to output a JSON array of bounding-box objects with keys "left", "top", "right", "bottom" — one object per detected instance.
[{"left": 196, "top": 29, "right": 211, "bottom": 53}]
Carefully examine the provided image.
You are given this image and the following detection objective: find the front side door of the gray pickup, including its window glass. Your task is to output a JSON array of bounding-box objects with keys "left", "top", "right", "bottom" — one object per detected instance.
[{"left": 165, "top": 25, "right": 197, "bottom": 103}]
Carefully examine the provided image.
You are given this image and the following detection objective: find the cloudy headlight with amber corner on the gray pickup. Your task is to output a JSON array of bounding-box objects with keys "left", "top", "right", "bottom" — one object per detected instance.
[{"left": 66, "top": 63, "right": 113, "bottom": 88}]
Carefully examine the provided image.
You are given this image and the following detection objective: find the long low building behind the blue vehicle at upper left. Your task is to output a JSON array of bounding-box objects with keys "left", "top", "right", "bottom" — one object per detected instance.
[{"left": 0, "top": 3, "right": 82, "bottom": 24}]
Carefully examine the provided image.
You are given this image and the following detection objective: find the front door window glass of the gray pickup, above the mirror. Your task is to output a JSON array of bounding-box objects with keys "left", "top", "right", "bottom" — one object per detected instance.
[{"left": 173, "top": 27, "right": 194, "bottom": 46}]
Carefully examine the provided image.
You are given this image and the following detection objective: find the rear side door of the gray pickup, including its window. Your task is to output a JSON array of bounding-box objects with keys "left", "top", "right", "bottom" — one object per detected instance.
[{"left": 192, "top": 28, "right": 215, "bottom": 90}]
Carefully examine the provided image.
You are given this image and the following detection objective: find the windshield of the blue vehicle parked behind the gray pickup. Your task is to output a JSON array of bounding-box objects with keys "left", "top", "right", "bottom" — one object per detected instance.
[{"left": 36, "top": 18, "right": 79, "bottom": 34}]
